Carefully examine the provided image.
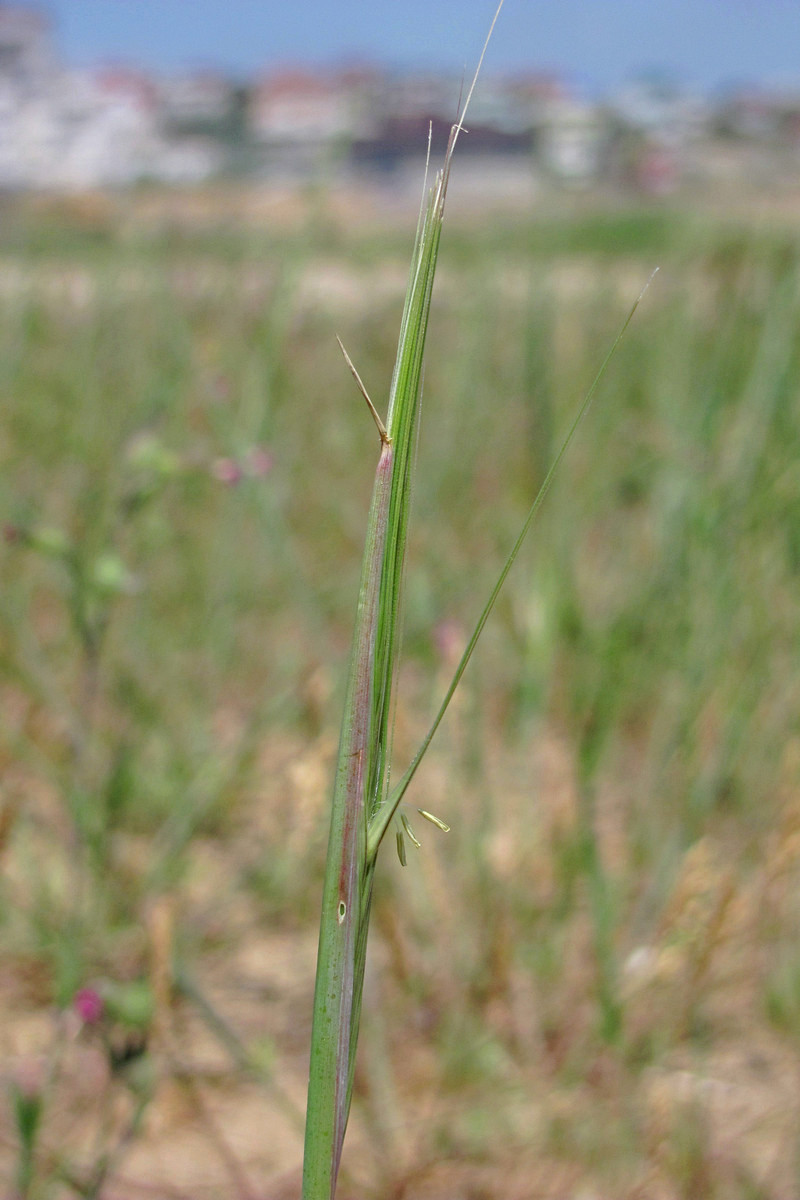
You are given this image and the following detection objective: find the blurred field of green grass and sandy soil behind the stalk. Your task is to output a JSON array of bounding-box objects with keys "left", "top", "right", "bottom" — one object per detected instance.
[{"left": 0, "top": 176, "right": 800, "bottom": 1200}]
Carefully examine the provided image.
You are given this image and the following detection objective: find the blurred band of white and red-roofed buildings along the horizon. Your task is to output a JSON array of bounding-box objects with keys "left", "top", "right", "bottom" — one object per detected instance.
[{"left": 0, "top": 0, "right": 800, "bottom": 198}]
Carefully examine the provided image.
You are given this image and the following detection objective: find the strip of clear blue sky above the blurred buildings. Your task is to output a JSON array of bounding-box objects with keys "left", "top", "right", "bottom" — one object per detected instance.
[{"left": 28, "top": 0, "right": 800, "bottom": 92}]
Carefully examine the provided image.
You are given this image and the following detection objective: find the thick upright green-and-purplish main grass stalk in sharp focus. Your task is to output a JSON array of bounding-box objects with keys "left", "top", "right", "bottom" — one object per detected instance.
[{"left": 303, "top": 112, "right": 456, "bottom": 1200}]
